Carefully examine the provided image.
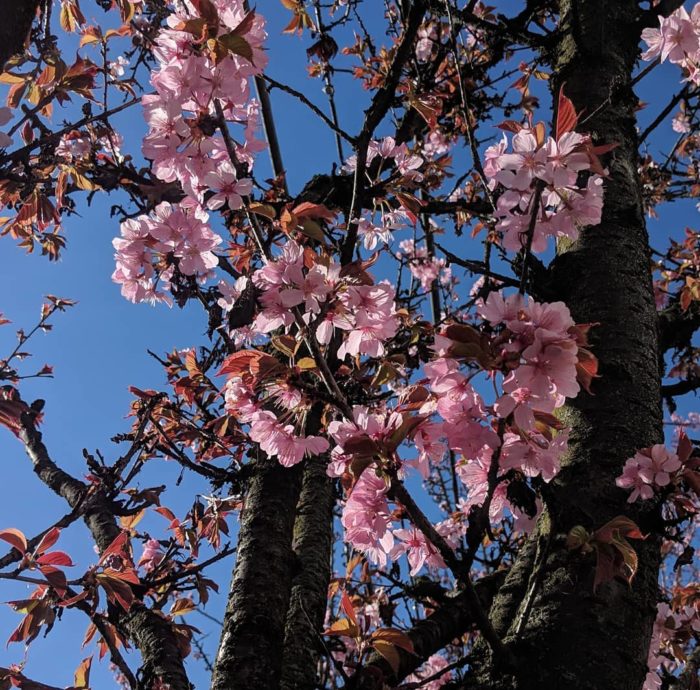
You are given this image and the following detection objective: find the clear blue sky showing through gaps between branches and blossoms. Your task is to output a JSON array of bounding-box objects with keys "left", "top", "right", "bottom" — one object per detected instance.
[{"left": 0, "top": 1, "right": 697, "bottom": 687}]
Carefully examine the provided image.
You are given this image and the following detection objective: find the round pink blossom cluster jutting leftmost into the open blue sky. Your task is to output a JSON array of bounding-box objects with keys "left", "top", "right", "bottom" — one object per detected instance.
[{"left": 112, "top": 201, "right": 222, "bottom": 302}]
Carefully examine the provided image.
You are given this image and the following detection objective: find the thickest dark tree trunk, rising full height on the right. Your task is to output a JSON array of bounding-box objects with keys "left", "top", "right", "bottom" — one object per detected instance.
[{"left": 476, "top": 0, "right": 662, "bottom": 690}]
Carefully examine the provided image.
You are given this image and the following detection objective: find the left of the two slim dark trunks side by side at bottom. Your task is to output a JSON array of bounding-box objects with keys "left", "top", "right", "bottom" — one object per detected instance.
[{"left": 212, "top": 453, "right": 302, "bottom": 690}]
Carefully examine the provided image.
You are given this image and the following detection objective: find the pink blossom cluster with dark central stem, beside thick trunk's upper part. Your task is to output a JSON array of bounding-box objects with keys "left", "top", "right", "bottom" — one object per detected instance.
[{"left": 484, "top": 125, "right": 603, "bottom": 252}]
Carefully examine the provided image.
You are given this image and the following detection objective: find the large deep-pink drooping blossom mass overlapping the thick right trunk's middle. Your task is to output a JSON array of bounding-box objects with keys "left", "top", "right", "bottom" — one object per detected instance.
[{"left": 422, "top": 292, "right": 584, "bottom": 510}]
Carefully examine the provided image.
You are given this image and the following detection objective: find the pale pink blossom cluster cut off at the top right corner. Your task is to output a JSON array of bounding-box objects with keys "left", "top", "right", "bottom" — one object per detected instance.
[{"left": 642, "top": 3, "right": 700, "bottom": 84}]
